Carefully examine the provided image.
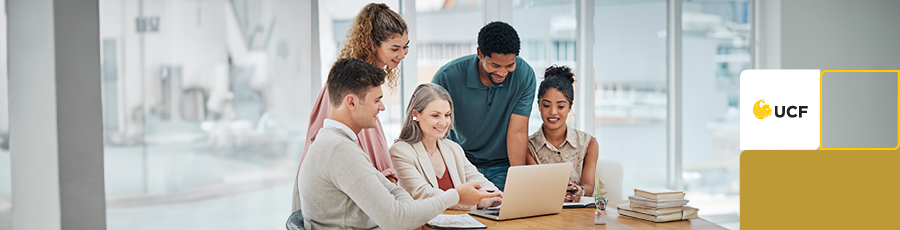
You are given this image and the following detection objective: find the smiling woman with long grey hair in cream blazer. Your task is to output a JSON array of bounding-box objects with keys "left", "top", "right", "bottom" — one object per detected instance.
[{"left": 390, "top": 83, "right": 502, "bottom": 210}]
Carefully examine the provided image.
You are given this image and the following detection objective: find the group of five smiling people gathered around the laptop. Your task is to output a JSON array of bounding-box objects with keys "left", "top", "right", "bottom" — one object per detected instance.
[{"left": 293, "top": 3, "right": 605, "bottom": 229}]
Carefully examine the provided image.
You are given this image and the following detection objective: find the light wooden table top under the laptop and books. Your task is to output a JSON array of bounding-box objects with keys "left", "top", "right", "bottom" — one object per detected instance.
[{"left": 422, "top": 201, "right": 725, "bottom": 230}]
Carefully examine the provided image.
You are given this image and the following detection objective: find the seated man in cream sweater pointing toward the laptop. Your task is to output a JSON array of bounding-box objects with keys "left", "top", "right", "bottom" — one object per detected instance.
[{"left": 297, "top": 58, "right": 499, "bottom": 229}]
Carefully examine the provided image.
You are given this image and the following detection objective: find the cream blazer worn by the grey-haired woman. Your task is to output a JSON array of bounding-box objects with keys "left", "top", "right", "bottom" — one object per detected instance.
[{"left": 391, "top": 139, "right": 497, "bottom": 210}]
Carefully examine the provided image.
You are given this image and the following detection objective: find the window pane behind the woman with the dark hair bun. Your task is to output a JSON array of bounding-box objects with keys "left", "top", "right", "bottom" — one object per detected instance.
[{"left": 512, "top": 0, "right": 578, "bottom": 135}]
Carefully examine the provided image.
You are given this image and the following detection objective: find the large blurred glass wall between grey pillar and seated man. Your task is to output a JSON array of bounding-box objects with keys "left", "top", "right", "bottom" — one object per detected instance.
[{"left": 99, "top": 0, "right": 313, "bottom": 229}]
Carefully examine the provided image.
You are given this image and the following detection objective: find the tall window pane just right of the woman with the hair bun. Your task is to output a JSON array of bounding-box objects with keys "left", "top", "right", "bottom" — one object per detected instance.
[{"left": 594, "top": 0, "right": 667, "bottom": 190}]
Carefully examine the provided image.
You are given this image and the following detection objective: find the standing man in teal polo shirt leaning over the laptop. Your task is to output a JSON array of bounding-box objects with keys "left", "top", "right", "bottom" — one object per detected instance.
[{"left": 431, "top": 22, "right": 537, "bottom": 190}]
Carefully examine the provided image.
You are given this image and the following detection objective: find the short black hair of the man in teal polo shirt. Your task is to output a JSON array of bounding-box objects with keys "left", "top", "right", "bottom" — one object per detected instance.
[{"left": 478, "top": 21, "right": 520, "bottom": 57}]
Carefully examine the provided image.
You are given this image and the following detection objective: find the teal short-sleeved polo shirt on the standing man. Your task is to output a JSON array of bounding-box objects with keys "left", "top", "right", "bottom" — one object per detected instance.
[{"left": 431, "top": 54, "right": 537, "bottom": 168}]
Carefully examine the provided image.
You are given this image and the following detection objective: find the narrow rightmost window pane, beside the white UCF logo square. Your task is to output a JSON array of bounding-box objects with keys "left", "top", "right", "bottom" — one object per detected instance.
[{"left": 681, "top": 0, "right": 751, "bottom": 228}]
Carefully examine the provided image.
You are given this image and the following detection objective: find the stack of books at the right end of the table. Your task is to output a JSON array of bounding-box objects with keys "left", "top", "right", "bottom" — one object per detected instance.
[{"left": 617, "top": 188, "right": 699, "bottom": 223}]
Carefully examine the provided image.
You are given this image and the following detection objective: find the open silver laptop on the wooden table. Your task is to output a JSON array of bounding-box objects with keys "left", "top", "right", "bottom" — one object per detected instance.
[{"left": 468, "top": 163, "right": 572, "bottom": 220}]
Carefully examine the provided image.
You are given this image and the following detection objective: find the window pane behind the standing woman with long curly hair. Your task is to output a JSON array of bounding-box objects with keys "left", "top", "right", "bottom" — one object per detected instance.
[{"left": 316, "top": 0, "right": 400, "bottom": 142}]
